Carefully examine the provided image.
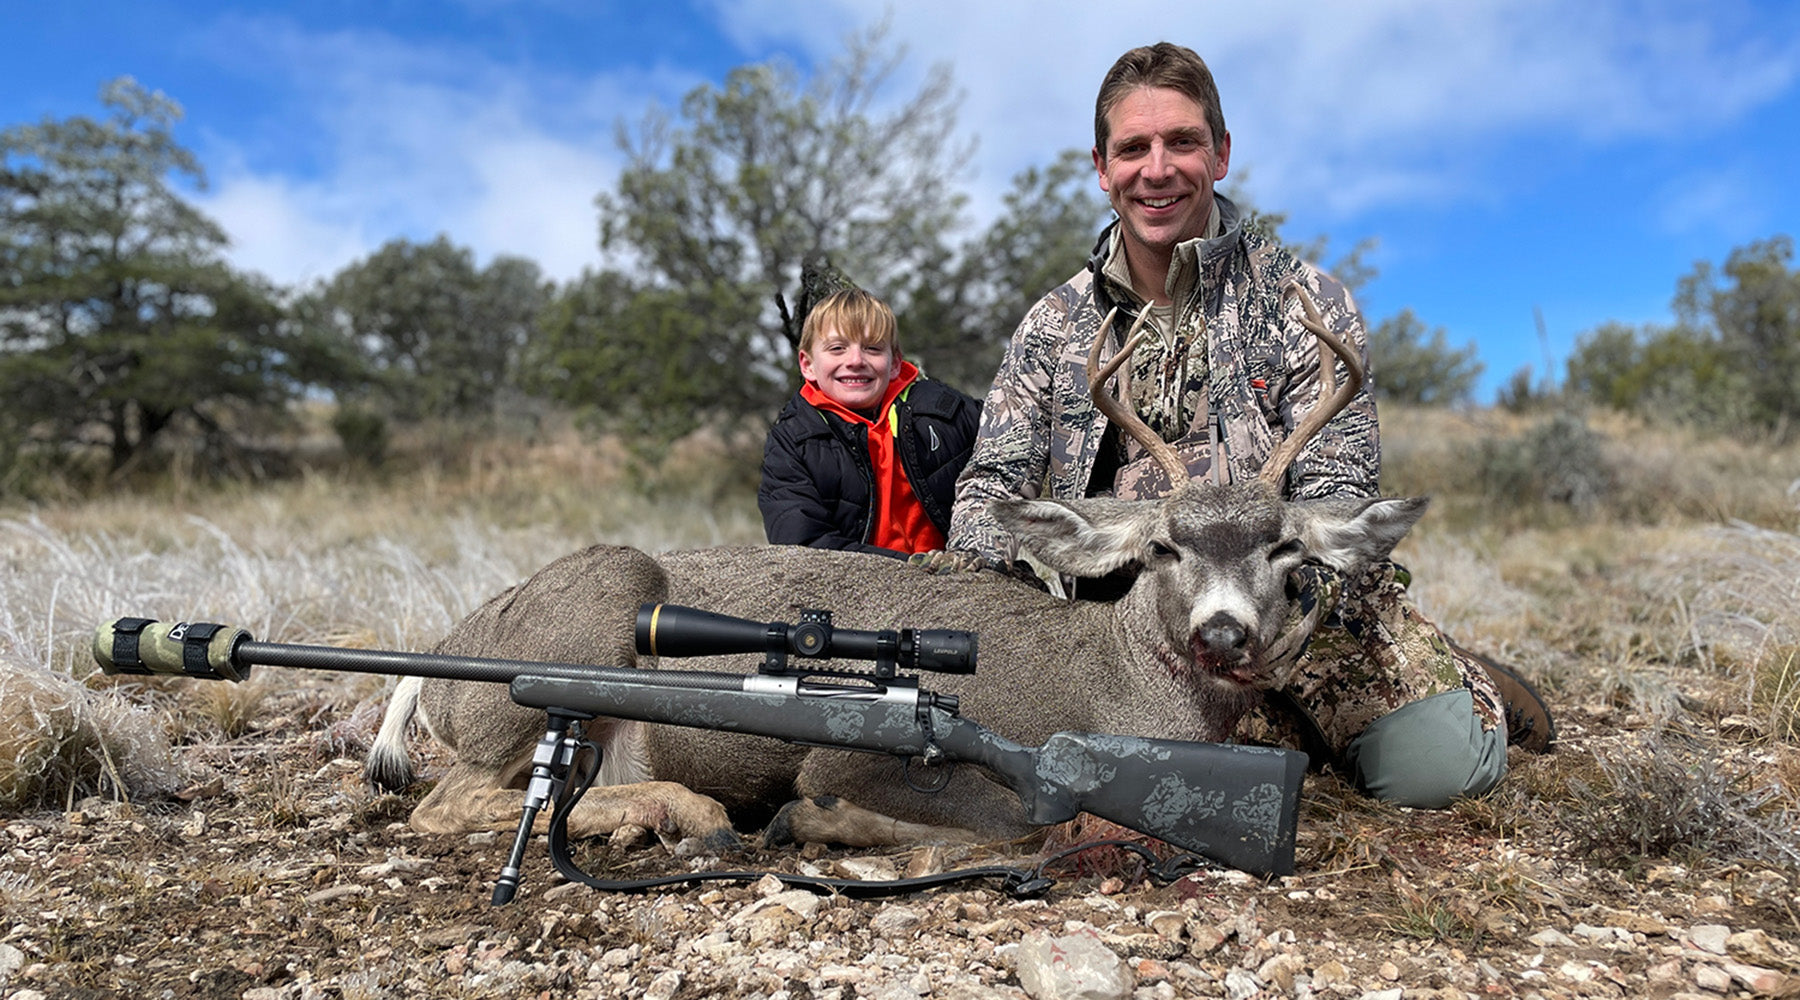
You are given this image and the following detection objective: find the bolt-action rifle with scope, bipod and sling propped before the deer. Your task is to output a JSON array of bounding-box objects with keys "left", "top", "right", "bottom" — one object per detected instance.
[{"left": 94, "top": 604, "right": 1307, "bottom": 905}]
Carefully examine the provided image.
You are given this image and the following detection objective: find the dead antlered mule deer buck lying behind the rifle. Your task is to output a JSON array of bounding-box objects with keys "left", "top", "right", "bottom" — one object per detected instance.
[{"left": 367, "top": 286, "right": 1426, "bottom": 845}]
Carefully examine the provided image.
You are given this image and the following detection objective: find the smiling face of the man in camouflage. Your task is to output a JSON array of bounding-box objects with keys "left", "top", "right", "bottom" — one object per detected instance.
[{"left": 1094, "top": 86, "right": 1231, "bottom": 266}]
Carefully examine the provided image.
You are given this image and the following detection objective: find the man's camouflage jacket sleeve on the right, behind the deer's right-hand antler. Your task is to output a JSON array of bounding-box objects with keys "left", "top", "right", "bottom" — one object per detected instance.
[{"left": 1278, "top": 264, "right": 1381, "bottom": 500}]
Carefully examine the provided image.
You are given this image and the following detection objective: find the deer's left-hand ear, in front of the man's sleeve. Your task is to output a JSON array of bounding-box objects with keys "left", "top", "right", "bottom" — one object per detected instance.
[{"left": 988, "top": 498, "right": 1161, "bottom": 577}]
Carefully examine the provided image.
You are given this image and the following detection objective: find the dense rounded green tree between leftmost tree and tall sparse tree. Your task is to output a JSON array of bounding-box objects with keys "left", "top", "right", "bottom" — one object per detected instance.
[{"left": 304, "top": 236, "right": 551, "bottom": 419}]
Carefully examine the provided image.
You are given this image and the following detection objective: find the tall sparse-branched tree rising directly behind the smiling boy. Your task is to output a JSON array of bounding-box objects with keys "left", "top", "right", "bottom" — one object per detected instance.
[{"left": 586, "top": 31, "right": 963, "bottom": 429}]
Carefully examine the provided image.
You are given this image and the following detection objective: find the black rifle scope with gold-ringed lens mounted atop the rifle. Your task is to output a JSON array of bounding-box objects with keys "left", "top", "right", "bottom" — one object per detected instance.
[{"left": 637, "top": 604, "right": 976, "bottom": 674}]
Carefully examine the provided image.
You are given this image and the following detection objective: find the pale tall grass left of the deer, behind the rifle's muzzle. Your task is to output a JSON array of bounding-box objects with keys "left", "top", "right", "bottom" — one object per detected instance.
[{"left": 0, "top": 424, "right": 761, "bottom": 808}]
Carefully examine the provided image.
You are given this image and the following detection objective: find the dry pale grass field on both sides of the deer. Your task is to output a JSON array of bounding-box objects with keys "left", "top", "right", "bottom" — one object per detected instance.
[{"left": 0, "top": 408, "right": 1800, "bottom": 877}]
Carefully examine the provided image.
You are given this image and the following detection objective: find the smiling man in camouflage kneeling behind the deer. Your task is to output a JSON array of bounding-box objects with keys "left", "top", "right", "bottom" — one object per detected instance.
[{"left": 916, "top": 43, "right": 1550, "bottom": 808}]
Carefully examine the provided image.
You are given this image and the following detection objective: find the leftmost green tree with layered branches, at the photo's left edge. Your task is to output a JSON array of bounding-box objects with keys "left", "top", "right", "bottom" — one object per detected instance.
[{"left": 0, "top": 77, "right": 306, "bottom": 471}]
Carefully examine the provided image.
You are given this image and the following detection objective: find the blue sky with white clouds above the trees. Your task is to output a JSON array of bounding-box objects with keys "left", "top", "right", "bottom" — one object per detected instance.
[{"left": 0, "top": 0, "right": 1800, "bottom": 399}]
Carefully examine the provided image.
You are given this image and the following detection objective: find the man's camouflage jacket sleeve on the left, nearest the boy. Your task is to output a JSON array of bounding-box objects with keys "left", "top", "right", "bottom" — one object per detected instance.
[{"left": 945, "top": 288, "right": 1069, "bottom": 565}]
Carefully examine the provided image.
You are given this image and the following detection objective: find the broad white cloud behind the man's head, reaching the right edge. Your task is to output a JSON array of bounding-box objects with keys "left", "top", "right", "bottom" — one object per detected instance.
[{"left": 722, "top": 0, "right": 1800, "bottom": 223}]
